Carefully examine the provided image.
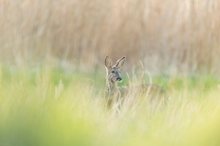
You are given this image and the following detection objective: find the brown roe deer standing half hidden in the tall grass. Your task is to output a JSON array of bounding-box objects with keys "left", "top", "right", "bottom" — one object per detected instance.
[{"left": 105, "top": 56, "right": 164, "bottom": 107}]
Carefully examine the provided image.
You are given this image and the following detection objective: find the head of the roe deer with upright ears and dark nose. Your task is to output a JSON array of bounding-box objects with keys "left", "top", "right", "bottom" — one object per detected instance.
[{"left": 105, "top": 56, "right": 125, "bottom": 83}]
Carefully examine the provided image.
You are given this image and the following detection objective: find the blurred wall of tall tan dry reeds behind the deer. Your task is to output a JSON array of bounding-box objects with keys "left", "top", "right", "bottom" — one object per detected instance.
[{"left": 0, "top": 0, "right": 220, "bottom": 73}]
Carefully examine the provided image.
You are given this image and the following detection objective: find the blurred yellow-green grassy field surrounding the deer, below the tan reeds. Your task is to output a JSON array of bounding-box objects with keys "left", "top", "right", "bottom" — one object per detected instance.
[{"left": 0, "top": 65, "right": 220, "bottom": 146}]
